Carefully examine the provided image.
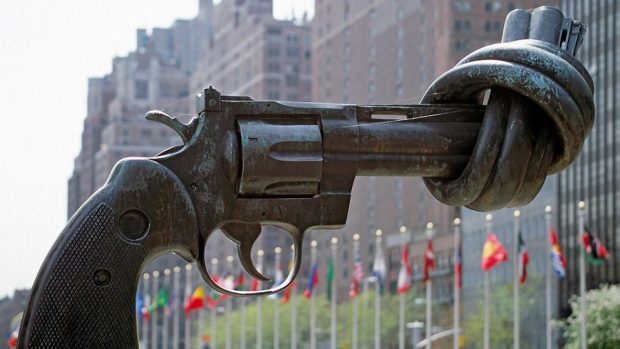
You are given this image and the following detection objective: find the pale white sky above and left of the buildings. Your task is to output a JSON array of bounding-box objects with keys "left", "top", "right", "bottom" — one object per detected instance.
[{"left": 0, "top": 0, "right": 314, "bottom": 298}]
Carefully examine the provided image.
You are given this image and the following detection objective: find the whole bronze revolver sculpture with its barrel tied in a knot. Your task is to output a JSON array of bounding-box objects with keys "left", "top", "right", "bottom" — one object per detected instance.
[{"left": 18, "top": 7, "right": 594, "bottom": 348}]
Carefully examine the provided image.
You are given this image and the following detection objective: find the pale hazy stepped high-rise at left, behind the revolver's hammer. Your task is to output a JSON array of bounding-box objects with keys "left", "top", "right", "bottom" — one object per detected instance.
[{"left": 67, "top": 6, "right": 208, "bottom": 216}]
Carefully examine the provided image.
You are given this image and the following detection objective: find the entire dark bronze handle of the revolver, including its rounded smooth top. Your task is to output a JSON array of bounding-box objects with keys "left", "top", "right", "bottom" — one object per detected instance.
[{"left": 18, "top": 159, "right": 198, "bottom": 348}]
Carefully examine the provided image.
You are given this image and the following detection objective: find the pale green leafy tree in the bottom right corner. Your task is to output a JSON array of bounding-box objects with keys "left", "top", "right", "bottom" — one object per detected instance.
[{"left": 562, "top": 285, "right": 620, "bottom": 349}]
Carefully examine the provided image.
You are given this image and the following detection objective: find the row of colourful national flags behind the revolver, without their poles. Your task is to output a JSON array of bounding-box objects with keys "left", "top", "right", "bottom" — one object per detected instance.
[{"left": 136, "top": 223, "right": 609, "bottom": 320}]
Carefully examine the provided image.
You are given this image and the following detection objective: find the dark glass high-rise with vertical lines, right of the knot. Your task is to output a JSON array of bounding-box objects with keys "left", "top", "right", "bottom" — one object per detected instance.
[{"left": 558, "top": 0, "right": 620, "bottom": 316}]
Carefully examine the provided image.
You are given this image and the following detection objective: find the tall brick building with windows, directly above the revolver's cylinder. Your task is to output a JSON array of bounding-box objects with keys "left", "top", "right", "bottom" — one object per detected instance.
[{"left": 191, "top": 0, "right": 312, "bottom": 101}]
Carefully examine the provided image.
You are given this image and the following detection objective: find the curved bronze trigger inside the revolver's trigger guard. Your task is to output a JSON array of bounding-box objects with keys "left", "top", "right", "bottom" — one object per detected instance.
[{"left": 221, "top": 223, "right": 271, "bottom": 281}]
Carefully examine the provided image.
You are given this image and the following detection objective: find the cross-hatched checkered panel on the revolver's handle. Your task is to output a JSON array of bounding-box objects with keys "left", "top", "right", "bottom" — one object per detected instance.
[{"left": 29, "top": 203, "right": 145, "bottom": 348}]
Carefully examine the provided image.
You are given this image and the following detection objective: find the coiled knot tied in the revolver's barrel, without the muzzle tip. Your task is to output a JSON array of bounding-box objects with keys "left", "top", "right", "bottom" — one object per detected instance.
[{"left": 422, "top": 34, "right": 594, "bottom": 211}]
